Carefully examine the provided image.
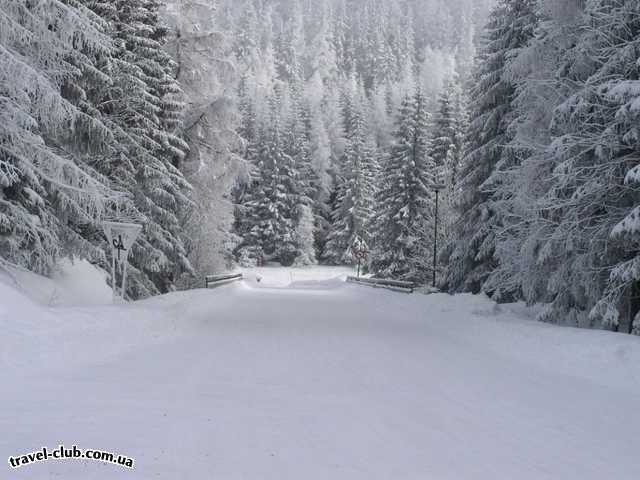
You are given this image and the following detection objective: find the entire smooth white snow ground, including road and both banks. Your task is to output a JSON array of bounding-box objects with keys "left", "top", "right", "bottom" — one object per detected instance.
[{"left": 0, "top": 268, "right": 640, "bottom": 480}]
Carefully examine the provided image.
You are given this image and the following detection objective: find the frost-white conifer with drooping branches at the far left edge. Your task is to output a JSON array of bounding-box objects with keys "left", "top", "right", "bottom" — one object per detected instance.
[{"left": 0, "top": 0, "right": 114, "bottom": 273}]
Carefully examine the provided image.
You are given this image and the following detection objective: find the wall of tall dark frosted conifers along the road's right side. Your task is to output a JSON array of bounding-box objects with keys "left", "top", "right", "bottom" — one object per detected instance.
[{"left": 443, "top": 0, "right": 640, "bottom": 333}]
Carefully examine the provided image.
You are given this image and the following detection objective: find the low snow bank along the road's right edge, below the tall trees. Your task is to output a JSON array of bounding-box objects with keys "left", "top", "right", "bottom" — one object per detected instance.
[{"left": 404, "top": 294, "right": 640, "bottom": 392}]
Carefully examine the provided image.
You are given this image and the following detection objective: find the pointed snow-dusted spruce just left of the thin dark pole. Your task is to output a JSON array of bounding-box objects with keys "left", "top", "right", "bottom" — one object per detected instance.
[{"left": 371, "top": 92, "right": 434, "bottom": 281}]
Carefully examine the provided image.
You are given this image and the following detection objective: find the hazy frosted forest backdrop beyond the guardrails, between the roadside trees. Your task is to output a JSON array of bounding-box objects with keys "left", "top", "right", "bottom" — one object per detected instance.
[{"left": 230, "top": 0, "right": 476, "bottom": 280}]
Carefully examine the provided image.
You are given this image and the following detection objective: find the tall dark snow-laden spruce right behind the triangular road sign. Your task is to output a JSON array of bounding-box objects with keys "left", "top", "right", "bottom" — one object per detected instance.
[{"left": 83, "top": 0, "right": 192, "bottom": 298}]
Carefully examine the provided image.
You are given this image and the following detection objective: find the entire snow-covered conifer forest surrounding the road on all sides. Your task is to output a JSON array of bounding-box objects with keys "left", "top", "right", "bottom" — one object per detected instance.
[{"left": 0, "top": 0, "right": 640, "bottom": 334}]
